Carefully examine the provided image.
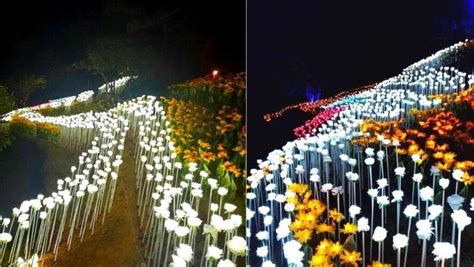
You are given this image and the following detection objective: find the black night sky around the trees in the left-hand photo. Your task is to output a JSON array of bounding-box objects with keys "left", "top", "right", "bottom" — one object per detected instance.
[{"left": 0, "top": 0, "right": 245, "bottom": 101}]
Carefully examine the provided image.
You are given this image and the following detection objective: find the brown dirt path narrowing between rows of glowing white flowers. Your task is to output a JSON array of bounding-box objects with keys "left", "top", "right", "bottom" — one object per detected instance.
[{"left": 45, "top": 140, "right": 144, "bottom": 267}]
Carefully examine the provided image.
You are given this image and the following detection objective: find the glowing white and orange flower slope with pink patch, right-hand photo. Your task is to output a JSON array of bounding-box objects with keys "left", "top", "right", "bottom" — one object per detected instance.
[{"left": 247, "top": 40, "right": 474, "bottom": 266}]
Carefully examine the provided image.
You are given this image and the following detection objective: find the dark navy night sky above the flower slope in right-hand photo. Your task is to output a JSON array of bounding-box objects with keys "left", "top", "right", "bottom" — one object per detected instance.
[{"left": 247, "top": 0, "right": 474, "bottom": 167}]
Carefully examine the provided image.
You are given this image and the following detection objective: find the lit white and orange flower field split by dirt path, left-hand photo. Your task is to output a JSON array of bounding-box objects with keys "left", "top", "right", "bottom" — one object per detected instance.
[{"left": 0, "top": 75, "right": 245, "bottom": 266}]
